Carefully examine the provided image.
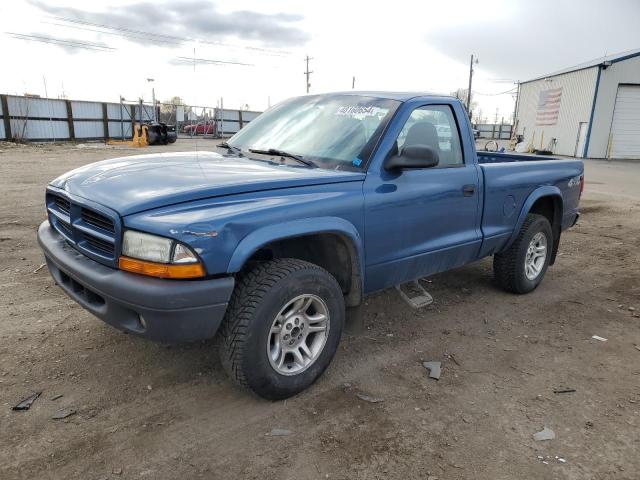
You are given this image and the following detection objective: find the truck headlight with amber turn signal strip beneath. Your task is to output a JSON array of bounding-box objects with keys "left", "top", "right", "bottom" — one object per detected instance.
[{"left": 118, "top": 230, "right": 205, "bottom": 278}]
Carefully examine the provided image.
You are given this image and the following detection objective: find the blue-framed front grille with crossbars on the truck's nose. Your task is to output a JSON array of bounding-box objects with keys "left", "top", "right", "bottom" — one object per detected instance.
[{"left": 47, "top": 191, "right": 121, "bottom": 267}]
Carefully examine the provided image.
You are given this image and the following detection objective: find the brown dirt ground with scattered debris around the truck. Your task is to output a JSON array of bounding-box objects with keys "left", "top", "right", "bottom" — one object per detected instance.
[{"left": 0, "top": 142, "right": 640, "bottom": 480}]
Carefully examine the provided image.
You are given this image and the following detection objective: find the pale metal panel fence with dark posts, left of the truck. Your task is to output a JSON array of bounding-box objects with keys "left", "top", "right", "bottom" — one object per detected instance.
[{"left": 0, "top": 95, "right": 261, "bottom": 141}]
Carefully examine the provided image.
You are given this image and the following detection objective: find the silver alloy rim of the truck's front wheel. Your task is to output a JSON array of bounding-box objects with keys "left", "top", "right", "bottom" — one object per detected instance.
[{"left": 267, "top": 294, "right": 330, "bottom": 375}]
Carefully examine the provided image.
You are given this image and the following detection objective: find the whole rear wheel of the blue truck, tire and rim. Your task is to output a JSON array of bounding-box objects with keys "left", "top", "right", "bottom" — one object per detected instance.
[{"left": 493, "top": 214, "right": 553, "bottom": 293}]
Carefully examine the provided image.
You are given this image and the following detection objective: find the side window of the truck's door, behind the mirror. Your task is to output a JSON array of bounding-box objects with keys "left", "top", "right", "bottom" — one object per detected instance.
[{"left": 397, "top": 105, "right": 464, "bottom": 167}]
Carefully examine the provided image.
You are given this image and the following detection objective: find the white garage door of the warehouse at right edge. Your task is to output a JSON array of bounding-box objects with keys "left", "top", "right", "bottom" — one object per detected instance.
[{"left": 609, "top": 85, "right": 640, "bottom": 158}]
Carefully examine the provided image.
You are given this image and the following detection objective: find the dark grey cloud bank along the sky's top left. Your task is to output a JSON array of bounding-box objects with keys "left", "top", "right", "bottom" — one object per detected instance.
[{"left": 30, "top": 0, "right": 310, "bottom": 48}]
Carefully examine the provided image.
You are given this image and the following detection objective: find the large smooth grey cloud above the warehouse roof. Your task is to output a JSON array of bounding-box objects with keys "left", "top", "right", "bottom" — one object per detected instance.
[{"left": 426, "top": 0, "right": 640, "bottom": 80}]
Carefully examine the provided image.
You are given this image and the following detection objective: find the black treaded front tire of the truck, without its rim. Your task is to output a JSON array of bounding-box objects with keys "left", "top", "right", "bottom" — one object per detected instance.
[{"left": 220, "top": 258, "right": 345, "bottom": 400}]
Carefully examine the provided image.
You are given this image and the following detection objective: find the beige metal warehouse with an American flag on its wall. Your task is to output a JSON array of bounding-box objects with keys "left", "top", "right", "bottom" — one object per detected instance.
[{"left": 516, "top": 49, "right": 640, "bottom": 159}]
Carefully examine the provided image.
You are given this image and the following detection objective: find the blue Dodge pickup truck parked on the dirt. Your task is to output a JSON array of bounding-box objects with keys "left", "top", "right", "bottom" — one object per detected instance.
[{"left": 38, "top": 92, "right": 584, "bottom": 399}]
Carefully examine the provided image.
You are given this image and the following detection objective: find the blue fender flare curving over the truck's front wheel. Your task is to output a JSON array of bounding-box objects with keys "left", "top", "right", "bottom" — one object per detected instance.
[{"left": 227, "top": 217, "right": 364, "bottom": 285}]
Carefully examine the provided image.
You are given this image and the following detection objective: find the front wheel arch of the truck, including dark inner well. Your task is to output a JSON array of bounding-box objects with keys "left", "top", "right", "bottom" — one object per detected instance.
[{"left": 227, "top": 217, "right": 364, "bottom": 307}]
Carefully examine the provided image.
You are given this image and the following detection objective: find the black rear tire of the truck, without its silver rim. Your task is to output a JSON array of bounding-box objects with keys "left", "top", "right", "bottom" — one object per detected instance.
[{"left": 493, "top": 213, "right": 553, "bottom": 293}]
